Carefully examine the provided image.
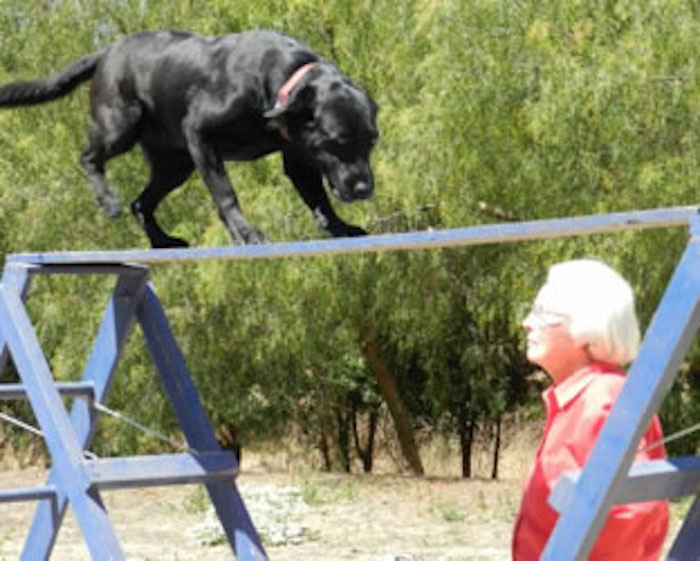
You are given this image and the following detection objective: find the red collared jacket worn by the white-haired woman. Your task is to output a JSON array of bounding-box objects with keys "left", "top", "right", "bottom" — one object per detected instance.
[{"left": 513, "top": 363, "right": 669, "bottom": 561}]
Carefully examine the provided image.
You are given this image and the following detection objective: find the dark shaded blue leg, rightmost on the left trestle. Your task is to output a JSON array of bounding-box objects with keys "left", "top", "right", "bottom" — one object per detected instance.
[{"left": 138, "top": 283, "right": 267, "bottom": 561}]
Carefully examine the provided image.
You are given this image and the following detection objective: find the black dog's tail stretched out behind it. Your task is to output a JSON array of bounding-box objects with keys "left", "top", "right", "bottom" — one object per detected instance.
[{"left": 0, "top": 51, "right": 104, "bottom": 107}]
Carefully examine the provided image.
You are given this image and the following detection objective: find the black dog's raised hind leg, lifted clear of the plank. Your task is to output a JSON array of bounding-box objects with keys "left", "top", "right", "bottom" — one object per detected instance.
[{"left": 80, "top": 105, "right": 141, "bottom": 218}]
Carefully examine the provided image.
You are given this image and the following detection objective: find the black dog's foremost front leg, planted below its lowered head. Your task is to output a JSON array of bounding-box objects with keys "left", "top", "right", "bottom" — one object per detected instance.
[{"left": 283, "top": 152, "right": 367, "bottom": 238}]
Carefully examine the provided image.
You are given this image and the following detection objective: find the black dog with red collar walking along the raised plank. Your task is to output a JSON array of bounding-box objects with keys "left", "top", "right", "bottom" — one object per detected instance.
[{"left": 0, "top": 31, "right": 377, "bottom": 247}]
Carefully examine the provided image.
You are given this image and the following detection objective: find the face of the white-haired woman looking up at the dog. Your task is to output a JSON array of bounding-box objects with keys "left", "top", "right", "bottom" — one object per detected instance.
[{"left": 522, "top": 285, "right": 590, "bottom": 383}]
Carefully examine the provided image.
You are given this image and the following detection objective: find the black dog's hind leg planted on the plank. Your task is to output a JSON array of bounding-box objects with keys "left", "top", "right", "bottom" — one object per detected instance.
[{"left": 131, "top": 146, "right": 194, "bottom": 248}]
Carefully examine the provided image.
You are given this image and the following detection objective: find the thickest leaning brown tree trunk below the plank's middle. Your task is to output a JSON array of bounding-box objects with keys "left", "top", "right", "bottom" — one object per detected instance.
[{"left": 361, "top": 329, "right": 425, "bottom": 475}]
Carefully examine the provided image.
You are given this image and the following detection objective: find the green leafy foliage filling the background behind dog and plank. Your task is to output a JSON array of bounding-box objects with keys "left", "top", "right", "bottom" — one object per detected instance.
[{"left": 0, "top": 0, "right": 700, "bottom": 468}]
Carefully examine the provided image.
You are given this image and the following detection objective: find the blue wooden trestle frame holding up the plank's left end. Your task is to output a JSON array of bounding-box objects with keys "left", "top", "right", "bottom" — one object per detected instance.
[{"left": 0, "top": 263, "right": 267, "bottom": 561}]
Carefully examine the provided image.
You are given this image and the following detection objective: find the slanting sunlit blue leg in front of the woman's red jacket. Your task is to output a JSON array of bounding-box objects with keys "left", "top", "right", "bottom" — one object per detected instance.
[{"left": 542, "top": 218, "right": 700, "bottom": 561}]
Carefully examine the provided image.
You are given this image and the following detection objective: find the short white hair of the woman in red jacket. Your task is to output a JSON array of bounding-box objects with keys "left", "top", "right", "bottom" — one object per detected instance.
[{"left": 538, "top": 259, "right": 640, "bottom": 365}]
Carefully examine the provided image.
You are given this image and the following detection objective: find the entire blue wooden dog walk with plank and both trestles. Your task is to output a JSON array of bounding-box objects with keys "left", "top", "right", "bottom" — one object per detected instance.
[{"left": 0, "top": 203, "right": 700, "bottom": 561}]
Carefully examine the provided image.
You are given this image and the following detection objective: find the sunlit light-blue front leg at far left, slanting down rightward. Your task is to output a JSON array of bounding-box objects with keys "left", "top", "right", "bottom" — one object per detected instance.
[{"left": 0, "top": 278, "right": 124, "bottom": 560}]
